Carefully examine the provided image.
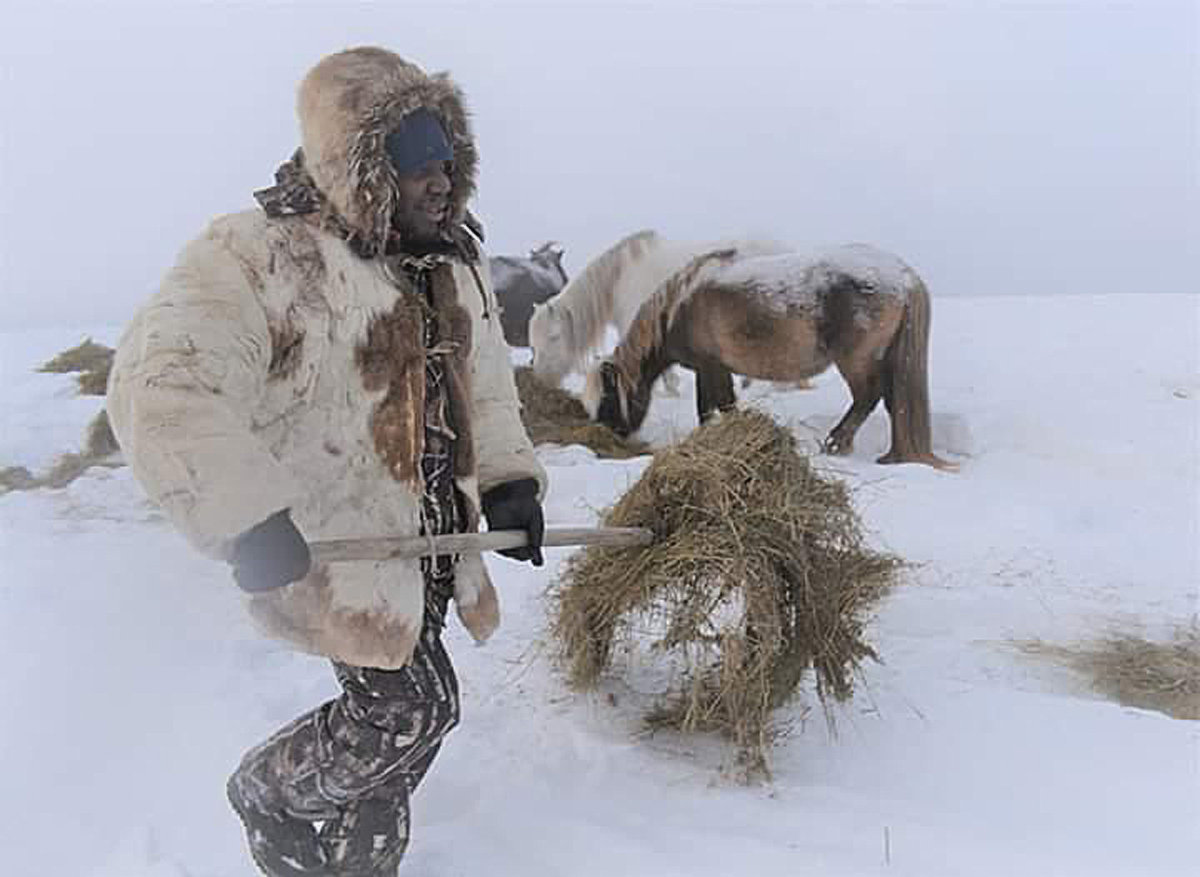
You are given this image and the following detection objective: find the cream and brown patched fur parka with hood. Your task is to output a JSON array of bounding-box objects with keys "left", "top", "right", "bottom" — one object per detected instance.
[{"left": 108, "top": 48, "right": 546, "bottom": 668}]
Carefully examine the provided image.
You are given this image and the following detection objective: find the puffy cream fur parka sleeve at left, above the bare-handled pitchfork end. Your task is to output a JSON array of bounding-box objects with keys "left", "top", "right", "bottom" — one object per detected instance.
[{"left": 107, "top": 230, "right": 296, "bottom": 558}]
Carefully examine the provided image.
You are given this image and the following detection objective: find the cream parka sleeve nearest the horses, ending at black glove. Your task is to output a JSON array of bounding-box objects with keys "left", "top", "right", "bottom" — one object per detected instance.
[{"left": 472, "top": 259, "right": 548, "bottom": 498}]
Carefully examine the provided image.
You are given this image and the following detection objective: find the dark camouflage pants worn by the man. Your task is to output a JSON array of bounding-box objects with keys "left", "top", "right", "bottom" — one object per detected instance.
[{"left": 227, "top": 573, "right": 458, "bottom": 877}]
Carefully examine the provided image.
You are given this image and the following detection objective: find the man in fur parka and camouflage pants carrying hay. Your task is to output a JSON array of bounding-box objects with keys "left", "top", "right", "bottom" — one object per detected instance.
[{"left": 108, "top": 48, "right": 546, "bottom": 877}]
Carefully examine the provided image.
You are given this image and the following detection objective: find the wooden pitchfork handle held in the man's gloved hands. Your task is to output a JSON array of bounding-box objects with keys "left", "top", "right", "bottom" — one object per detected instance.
[{"left": 308, "top": 527, "right": 654, "bottom": 564}]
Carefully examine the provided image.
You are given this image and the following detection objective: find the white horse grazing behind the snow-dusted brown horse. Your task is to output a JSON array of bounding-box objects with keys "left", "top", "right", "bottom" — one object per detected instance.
[{"left": 529, "top": 229, "right": 787, "bottom": 395}]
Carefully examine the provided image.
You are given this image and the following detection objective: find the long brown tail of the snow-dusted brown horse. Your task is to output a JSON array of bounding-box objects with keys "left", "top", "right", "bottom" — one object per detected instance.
[{"left": 878, "top": 278, "right": 958, "bottom": 469}]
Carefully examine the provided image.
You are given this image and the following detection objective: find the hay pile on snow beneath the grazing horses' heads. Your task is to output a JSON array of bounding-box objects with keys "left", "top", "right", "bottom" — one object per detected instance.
[{"left": 512, "top": 367, "right": 649, "bottom": 459}]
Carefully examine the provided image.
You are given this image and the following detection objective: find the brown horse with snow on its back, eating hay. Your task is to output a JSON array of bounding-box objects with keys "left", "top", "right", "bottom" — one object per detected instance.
[{"left": 583, "top": 244, "right": 956, "bottom": 469}]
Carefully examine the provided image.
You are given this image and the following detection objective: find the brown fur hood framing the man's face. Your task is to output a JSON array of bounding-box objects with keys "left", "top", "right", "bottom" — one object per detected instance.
[{"left": 296, "top": 47, "right": 479, "bottom": 252}]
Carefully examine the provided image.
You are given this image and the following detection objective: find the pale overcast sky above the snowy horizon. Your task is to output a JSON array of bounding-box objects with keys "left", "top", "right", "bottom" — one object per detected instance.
[{"left": 0, "top": 0, "right": 1200, "bottom": 329}]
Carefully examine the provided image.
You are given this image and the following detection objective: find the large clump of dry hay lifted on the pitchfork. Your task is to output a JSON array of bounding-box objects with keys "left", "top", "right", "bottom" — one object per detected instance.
[{"left": 552, "top": 409, "right": 901, "bottom": 780}]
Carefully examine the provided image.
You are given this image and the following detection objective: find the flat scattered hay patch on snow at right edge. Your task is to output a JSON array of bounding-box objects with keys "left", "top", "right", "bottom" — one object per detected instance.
[{"left": 1018, "top": 621, "right": 1200, "bottom": 720}]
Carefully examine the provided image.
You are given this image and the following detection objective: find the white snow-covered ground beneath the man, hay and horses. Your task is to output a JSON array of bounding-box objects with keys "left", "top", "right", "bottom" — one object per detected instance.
[{"left": 0, "top": 294, "right": 1200, "bottom": 877}]
